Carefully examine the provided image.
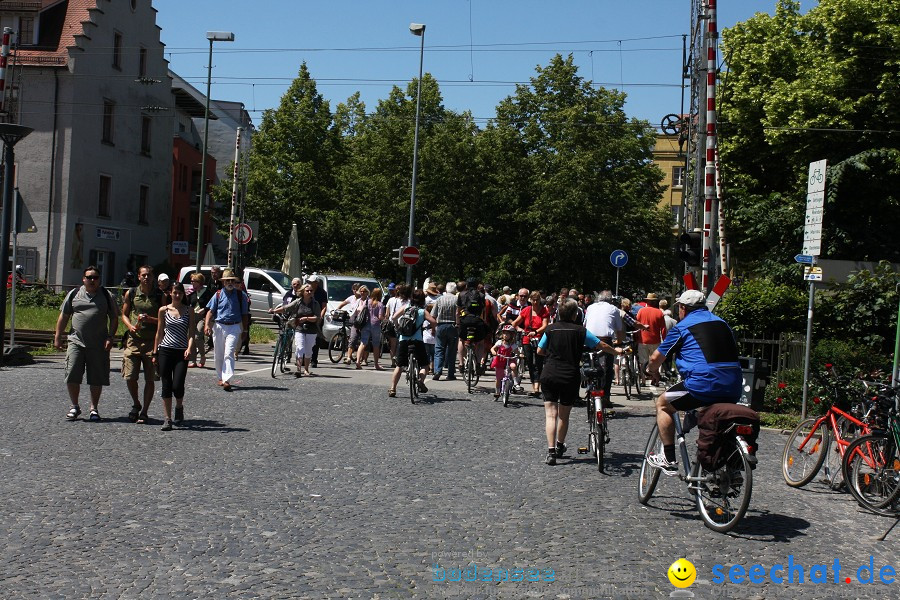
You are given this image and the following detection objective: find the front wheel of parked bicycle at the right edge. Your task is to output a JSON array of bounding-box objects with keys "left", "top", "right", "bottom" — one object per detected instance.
[{"left": 842, "top": 434, "right": 900, "bottom": 514}]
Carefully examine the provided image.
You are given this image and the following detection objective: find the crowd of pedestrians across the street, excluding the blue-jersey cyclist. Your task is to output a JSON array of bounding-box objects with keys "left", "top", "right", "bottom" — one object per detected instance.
[{"left": 54, "top": 266, "right": 716, "bottom": 464}]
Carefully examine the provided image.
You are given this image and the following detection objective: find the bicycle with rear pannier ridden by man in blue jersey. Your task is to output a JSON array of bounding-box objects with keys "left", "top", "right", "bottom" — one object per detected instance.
[{"left": 638, "top": 404, "right": 757, "bottom": 533}]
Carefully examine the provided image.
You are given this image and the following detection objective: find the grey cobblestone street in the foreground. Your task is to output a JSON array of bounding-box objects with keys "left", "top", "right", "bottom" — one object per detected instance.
[{"left": 0, "top": 346, "right": 900, "bottom": 600}]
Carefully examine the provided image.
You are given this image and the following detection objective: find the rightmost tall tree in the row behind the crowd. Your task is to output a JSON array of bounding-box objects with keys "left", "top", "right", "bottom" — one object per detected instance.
[{"left": 481, "top": 55, "right": 673, "bottom": 289}]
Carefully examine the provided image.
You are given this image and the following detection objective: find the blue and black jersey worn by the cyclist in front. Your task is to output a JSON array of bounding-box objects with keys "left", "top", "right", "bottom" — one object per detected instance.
[{"left": 658, "top": 308, "right": 743, "bottom": 402}]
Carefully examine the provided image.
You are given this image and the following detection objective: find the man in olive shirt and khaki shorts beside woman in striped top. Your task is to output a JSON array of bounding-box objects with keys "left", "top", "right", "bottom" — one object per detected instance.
[{"left": 122, "top": 265, "right": 164, "bottom": 424}]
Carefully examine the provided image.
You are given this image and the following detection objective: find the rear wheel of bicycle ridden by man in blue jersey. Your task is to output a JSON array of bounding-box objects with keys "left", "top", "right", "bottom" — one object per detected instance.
[{"left": 691, "top": 441, "right": 753, "bottom": 533}]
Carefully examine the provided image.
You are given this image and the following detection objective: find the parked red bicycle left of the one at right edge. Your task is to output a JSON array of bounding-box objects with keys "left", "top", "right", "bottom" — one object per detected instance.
[{"left": 781, "top": 365, "right": 872, "bottom": 487}]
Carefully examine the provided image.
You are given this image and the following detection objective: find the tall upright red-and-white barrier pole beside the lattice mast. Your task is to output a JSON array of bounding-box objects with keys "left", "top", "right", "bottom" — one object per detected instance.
[{"left": 701, "top": 0, "right": 719, "bottom": 290}]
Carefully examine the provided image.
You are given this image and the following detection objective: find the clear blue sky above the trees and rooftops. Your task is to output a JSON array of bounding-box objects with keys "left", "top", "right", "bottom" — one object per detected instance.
[{"left": 153, "top": 0, "right": 814, "bottom": 125}]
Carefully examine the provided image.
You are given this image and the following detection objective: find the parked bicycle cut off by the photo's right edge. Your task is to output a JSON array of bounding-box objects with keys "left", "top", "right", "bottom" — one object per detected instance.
[{"left": 841, "top": 386, "right": 900, "bottom": 516}]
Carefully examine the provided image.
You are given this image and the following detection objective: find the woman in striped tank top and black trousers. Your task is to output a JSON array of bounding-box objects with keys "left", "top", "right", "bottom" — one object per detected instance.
[{"left": 153, "top": 282, "right": 195, "bottom": 431}]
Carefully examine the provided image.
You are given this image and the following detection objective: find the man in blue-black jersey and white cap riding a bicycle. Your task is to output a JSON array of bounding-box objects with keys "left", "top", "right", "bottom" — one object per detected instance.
[{"left": 647, "top": 290, "right": 742, "bottom": 477}]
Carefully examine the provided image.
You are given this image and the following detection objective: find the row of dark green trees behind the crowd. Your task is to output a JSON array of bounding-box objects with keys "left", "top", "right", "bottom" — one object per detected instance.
[{"left": 236, "top": 56, "right": 673, "bottom": 290}]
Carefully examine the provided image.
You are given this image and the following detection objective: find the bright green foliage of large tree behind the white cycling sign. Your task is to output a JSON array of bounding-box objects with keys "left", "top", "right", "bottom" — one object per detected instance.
[{"left": 719, "top": 0, "right": 900, "bottom": 281}]
